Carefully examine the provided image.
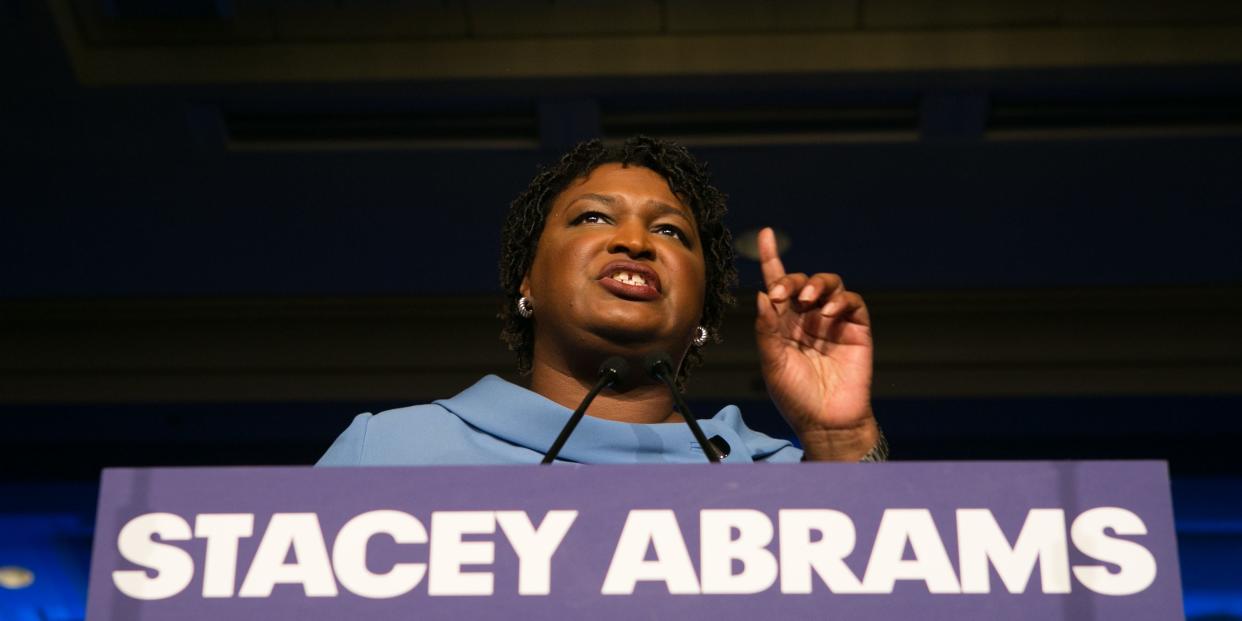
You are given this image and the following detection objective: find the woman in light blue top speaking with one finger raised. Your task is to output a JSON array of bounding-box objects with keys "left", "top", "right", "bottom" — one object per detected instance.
[{"left": 319, "top": 137, "right": 887, "bottom": 466}]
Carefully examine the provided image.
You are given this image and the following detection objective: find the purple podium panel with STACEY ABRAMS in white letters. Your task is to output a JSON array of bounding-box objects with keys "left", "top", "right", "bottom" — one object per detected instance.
[{"left": 87, "top": 462, "right": 1182, "bottom": 621}]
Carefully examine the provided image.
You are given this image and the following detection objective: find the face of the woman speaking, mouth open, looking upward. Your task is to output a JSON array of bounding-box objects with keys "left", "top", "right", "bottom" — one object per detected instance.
[{"left": 522, "top": 164, "right": 707, "bottom": 358}]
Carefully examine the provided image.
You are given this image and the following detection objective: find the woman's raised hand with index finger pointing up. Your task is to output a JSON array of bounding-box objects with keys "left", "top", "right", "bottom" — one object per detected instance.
[{"left": 755, "top": 229, "right": 879, "bottom": 461}]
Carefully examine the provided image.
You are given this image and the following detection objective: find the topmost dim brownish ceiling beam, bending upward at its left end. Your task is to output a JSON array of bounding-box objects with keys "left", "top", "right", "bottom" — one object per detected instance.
[{"left": 51, "top": 0, "right": 1242, "bottom": 86}]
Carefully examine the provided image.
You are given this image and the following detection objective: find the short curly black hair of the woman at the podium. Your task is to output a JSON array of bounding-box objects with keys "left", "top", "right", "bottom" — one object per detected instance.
[{"left": 499, "top": 135, "right": 738, "bottom": 385}]
